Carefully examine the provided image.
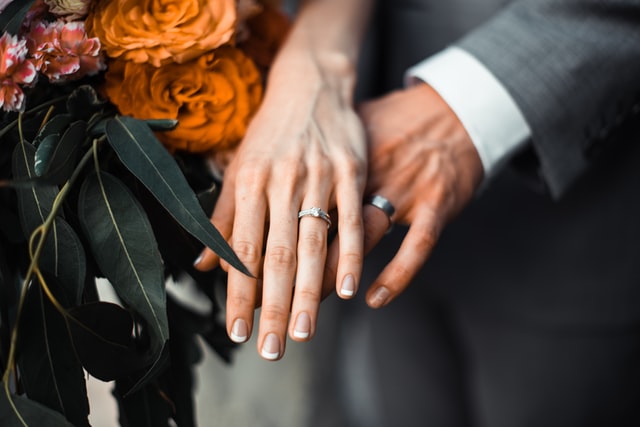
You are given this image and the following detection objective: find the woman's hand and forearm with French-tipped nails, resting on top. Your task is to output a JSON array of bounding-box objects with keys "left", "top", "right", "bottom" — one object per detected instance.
[{"left": 196, "top": 0, "right": 369, "bottom": 360}]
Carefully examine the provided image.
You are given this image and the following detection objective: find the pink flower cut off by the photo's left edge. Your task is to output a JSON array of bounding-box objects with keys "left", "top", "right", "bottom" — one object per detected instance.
[{"left": 0, "top": 33, "right": 38, "bottom": 111}]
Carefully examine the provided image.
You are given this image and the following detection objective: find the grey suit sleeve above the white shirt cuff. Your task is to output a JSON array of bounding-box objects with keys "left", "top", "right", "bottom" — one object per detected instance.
[{"left": 458, "top": 0, "right": 640, "bottom": 196}]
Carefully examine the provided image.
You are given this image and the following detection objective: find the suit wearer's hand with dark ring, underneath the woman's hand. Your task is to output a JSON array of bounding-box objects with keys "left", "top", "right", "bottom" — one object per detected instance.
[{"left": 324, "top": 83, "right": 483, "bottom": 308}]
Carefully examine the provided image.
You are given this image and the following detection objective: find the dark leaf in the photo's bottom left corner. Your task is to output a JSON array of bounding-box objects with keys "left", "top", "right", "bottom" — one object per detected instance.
[{"left": 0, "top": 388, "right": 74, "bottom": 427}]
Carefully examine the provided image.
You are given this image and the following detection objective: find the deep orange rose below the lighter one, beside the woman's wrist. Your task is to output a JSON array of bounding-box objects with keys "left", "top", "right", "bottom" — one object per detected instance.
[{"left": 104, "top": 46, "right": 262, "bottom": 153}]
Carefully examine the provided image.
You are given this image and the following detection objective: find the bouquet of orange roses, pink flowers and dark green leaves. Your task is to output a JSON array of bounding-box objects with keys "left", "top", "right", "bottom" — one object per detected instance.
[{"left": 0, "top": 0, "right": 288, "bottom": 426}]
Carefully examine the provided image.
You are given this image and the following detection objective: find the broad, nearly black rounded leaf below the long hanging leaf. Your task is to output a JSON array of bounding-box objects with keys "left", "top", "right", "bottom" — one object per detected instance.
[{"left": 69, "top": 302, "right": 145, "bottom": 381}]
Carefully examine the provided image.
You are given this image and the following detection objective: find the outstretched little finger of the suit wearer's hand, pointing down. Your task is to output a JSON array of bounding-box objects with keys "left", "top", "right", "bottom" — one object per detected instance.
[{"left": 366, "top": 211, "right": 441, "bottom": 308}]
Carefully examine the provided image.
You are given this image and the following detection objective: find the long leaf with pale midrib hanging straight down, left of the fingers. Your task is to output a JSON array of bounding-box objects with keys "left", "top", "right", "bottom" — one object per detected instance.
[{"left": 78, "top": 172, "right": 169, "bottom": 358}]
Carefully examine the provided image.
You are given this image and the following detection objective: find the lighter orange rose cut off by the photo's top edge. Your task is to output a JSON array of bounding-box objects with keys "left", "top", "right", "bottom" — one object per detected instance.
[{"left": 86, "top": 0, "right": 236, "bottom": 67}]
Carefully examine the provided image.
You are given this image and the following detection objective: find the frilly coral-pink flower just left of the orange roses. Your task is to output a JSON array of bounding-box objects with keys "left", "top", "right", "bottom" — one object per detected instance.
[{"left": 27, "top": 20, "right": 105, "bottom": 83}]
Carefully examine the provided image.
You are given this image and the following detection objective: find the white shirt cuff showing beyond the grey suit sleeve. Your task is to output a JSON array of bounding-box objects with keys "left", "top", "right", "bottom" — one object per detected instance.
[{"left": 406, "top": 46, "right": 531, "bottom": 177}]
